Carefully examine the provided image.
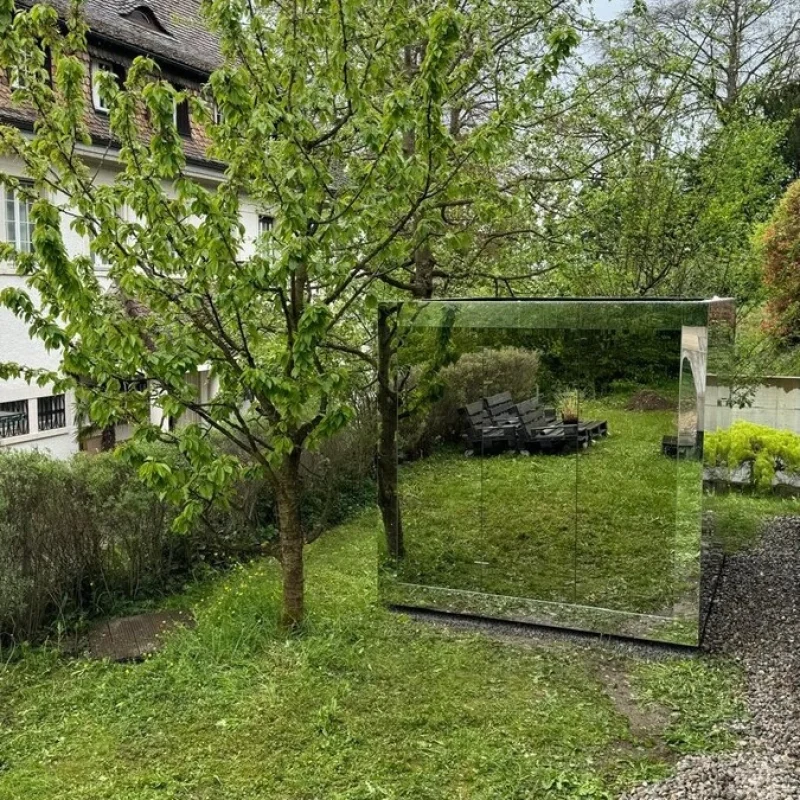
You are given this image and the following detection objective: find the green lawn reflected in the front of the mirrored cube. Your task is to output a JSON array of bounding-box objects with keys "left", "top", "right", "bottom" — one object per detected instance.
[{"left": 399, "top": 404, "right": 700, "bottom": 613}]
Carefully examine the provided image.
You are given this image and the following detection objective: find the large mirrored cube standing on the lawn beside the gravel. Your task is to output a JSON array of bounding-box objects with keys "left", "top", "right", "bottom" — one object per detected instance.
[{"left": 379, "top": 299, "right": 735, "bottom": 646}]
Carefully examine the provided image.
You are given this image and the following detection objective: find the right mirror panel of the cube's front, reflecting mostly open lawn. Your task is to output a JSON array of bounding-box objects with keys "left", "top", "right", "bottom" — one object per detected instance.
[{"left": 577, "top": 322, "right": 680, "bottom": 637}]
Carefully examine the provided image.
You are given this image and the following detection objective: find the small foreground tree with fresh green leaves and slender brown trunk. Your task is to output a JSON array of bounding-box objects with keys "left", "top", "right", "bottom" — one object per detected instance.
[{"left": 0, "top": 0, "right": 575, "bottom": 626}]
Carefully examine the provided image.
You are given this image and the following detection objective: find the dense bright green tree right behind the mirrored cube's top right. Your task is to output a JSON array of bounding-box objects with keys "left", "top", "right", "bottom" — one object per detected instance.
[{"left": 573, "top": 119, "right": 784, "bottom": 299}]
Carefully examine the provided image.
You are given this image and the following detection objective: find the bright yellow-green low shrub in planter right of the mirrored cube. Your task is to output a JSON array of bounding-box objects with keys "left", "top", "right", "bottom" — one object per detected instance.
[{"left": 703, "top": 420, "right": 800, "bottom": 490}]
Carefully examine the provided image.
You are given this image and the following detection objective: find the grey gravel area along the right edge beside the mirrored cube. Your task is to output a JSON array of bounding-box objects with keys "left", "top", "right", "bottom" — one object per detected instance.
[{"left": 626, "top": 517, "right": 800, "bottom": 800}]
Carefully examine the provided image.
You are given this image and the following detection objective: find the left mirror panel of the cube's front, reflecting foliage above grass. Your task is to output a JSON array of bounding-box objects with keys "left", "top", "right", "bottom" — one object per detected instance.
[{"left": 396, "top": 307, "right": 488, "bottom": 592}]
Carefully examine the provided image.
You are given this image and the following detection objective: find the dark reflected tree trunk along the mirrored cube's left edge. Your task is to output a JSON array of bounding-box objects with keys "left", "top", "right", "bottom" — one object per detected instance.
[{"left": 378, "top": 309, "right": 404, "bottom": 558}]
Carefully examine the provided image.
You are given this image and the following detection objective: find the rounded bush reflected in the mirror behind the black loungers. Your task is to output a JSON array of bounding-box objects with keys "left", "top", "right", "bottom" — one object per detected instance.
[{"left": 400, "top": 347, "right": 540, "bottom": 452}]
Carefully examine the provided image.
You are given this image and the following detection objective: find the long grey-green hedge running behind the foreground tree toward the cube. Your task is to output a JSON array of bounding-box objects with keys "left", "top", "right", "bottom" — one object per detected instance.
[{"left": 0, "top": 410, "right": 376, "bottom": 643}]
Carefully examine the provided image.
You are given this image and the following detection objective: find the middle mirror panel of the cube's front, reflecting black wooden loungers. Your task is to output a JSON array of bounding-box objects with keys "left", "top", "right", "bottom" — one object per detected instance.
[{"left": 482, "top": 320, "right": 577, "bottom": 608}]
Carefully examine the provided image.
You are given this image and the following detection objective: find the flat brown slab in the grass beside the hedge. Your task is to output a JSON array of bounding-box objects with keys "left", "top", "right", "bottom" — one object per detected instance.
[{"left": 86, "top": 611, "right": 195, "bottom": 661}]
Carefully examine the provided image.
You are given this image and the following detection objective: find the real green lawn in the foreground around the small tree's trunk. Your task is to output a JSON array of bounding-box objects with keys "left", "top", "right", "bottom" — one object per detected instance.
[{"left": 0, "top": 512, "right": 741, "bottom": 800}]
